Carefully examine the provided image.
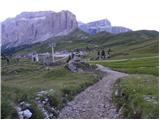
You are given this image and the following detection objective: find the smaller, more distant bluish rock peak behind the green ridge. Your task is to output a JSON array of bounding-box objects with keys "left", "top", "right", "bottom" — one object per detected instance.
[{"left": 78, "top": 19, "right": 131, "bottom": 34}]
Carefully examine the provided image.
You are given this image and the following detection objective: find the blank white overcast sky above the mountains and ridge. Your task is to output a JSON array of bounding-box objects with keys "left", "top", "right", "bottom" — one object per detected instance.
[{"left": 0, "top": 0, "right": 160, "bottom": 30}]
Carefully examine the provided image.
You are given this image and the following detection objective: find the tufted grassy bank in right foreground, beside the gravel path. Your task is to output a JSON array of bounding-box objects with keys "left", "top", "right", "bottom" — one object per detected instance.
[{"left": 113, "top": 75, "right": 159, "bottom": 119}]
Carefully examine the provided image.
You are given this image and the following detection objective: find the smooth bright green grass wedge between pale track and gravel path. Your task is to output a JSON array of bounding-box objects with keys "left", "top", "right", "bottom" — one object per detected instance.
[{"left": 90, "top": 57, "right": 159, "bottom": 76}]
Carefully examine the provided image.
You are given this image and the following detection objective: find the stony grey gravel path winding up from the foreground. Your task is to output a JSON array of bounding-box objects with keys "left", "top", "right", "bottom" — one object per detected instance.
[{"left": 59, "top": 65, "right": 127, "bottom": 119}]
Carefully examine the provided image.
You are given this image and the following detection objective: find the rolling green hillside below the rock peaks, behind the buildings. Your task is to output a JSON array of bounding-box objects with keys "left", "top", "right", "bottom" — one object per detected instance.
[{"left": 2, "top": 29, "right": 159, "bottom": 59}]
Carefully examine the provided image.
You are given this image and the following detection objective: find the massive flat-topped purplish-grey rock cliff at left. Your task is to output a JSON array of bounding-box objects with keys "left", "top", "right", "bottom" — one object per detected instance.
[{"left": 2, "top": 11, "right": 78, "bottom": 47}]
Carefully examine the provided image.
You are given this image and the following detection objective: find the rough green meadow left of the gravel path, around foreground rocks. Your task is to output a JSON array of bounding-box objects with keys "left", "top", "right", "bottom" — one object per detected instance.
[{"left": 1, "top": 59, "right": 100, "bottom": 118}]
